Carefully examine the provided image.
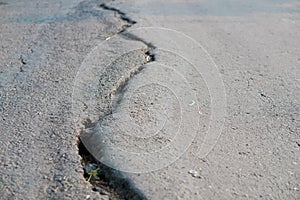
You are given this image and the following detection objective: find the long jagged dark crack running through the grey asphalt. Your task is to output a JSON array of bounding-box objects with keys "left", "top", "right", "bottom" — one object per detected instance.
[{"left": 78, "top": 3, "right": 156, "bottom": 199}]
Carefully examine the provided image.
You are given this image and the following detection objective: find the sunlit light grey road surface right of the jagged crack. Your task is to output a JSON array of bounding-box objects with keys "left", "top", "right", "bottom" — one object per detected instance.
[{"left": 78, "top": 0, "right": 300, "bottom": 199}]
